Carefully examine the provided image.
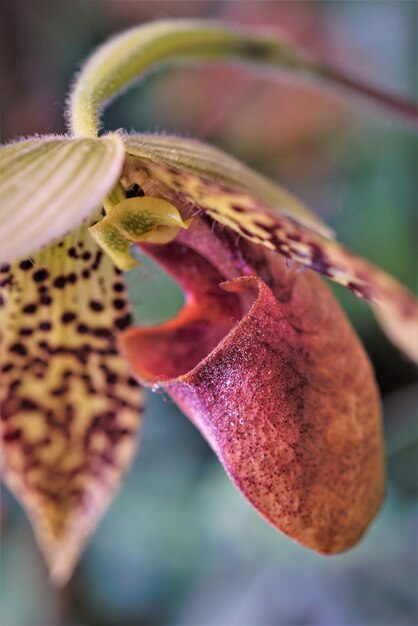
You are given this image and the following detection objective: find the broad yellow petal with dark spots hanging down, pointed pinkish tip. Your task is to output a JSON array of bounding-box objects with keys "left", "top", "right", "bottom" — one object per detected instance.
[{"left": 0, "top": 229, "right": 142, "bottom": 583}]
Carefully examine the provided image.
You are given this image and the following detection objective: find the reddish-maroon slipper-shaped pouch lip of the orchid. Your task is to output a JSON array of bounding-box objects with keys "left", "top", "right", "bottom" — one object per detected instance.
[{"left": 121, "top": 223, "right": 384, "bottom": 554}]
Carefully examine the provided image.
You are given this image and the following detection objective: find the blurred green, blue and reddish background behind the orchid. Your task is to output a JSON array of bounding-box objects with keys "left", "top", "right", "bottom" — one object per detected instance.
[{"left": 0, "top": 0, "right": 418, "bottom": 626}]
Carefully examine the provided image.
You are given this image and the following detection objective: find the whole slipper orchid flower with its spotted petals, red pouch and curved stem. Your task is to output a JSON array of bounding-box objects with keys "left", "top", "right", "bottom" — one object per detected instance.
[{"left": 0, "top": 20, "right": 418, "bottom": 584}]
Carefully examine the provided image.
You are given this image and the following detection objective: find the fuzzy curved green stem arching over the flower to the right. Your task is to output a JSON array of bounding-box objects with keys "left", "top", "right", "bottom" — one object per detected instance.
[{"left": 69, "top": 20, "right": 418, "bottom": 137}]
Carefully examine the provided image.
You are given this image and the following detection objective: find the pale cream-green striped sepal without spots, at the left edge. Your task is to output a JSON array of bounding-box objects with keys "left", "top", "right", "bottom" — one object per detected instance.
[{"left": 0, "top": 135, "right": 124, "bottom": 262}]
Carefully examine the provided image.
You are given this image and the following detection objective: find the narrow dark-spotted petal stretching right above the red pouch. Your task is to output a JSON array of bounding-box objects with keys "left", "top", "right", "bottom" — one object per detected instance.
[{"left": 122, "top": 138, "right": 418, "bottom": 361}]
